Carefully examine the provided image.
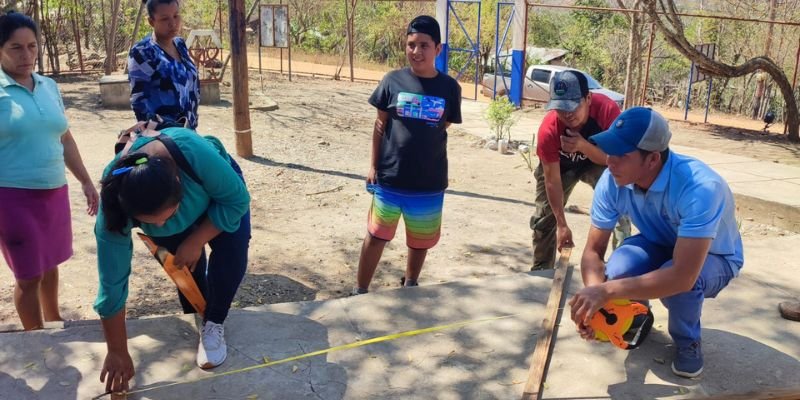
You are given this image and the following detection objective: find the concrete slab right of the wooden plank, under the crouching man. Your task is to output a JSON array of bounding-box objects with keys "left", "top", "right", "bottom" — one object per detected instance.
[{"left": 543, "top": 236, "right": 800, "bottom": 399}]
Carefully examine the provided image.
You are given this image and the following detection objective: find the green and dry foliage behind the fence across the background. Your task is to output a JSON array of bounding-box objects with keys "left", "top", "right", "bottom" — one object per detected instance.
[{"left": 32, "top": 0, "right": 800, "bottom": 121}]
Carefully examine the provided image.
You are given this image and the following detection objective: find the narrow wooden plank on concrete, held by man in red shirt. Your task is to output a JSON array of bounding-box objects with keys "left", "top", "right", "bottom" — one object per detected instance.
[{"left": 522, "top": 247, "right": 572, "bottom": 400}]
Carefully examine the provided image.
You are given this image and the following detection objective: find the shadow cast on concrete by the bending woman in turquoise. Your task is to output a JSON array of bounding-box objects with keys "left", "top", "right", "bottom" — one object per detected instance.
[{"left": 129, "top": 310, "right": 347, "bottom": 400}]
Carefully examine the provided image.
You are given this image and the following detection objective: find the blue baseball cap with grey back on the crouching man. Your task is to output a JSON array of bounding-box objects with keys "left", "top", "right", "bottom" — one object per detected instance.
[{"left": 589, "top": 107, "right": 672, "bottom": 156}]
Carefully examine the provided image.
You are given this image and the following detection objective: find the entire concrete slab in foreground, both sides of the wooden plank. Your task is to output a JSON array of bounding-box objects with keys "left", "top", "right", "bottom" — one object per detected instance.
[{"left": 0, "top": 231, "right": 800, "bottom": 399}]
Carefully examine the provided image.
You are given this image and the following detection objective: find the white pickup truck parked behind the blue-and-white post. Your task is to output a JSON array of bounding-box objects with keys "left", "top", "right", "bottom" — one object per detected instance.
[{"left": 481, "top": 65, "right": 625, "bottom": 108}]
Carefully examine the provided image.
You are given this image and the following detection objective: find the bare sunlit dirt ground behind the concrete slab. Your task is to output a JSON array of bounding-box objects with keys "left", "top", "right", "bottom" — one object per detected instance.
[{"left": 0, "top": 73, "right": 800, "bottom": 324}]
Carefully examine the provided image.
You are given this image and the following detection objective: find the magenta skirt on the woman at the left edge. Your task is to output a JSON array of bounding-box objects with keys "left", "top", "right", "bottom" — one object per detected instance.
[{"left": 0, "top": 185, "right": 72, "bottom": 280}]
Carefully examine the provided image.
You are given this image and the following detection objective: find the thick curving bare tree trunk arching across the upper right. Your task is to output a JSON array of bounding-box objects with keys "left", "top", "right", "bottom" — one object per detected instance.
[{"left": 645, "top": 0, "right": 800, "bottom": 142}]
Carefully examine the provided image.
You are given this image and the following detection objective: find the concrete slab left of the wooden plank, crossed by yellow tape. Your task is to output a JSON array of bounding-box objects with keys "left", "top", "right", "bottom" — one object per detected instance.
[{"left": 0, "top": 274, "right": 552, "bottom": 399}]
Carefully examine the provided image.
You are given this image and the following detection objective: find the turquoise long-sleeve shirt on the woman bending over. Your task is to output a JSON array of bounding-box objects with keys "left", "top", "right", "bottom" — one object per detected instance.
[{"left": 94, "top": 128, "right": 250, "bottom": 319}]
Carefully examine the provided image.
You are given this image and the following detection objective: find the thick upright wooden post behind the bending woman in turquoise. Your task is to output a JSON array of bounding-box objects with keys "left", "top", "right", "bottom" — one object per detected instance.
[{"left": 228, "top": 0, "right": 253, "bottom": 157}]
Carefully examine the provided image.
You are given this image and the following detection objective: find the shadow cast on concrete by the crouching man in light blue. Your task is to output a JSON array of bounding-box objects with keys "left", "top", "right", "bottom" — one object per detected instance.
[{"left": 608, "top": 329, "right": 800, "bottom": 399}]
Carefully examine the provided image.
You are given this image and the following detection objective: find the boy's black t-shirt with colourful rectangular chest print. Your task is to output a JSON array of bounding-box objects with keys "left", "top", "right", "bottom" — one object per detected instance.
[{"left": 369, "top": 68, "right": 461, "bottom": 191}]
